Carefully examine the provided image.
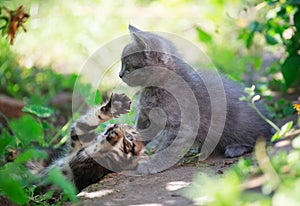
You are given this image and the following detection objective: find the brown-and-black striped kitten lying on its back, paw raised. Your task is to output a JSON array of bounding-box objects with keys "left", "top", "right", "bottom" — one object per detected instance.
[{"left": 27, "top": 94, "right": 144, "bottom": 191}]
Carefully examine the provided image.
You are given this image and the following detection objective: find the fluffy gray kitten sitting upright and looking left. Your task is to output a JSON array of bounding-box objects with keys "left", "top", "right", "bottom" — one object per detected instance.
[{"left": 119, "top": 25, "right": 271, "bottom": 173}]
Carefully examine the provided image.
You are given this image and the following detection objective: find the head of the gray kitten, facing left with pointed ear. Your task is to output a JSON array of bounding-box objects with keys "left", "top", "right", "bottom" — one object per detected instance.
[{"left": 119, "top": 25, "right": 179, "bottom": 86}]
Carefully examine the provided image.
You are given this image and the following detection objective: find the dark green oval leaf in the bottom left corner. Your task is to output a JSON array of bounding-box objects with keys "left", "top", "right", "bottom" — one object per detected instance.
[{"left": 0, "top": 172, "right": 28, "bottom": 204}]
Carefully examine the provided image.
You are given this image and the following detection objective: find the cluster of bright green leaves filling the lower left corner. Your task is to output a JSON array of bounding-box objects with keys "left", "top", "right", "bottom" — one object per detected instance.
[{"left": 0, "top": 110, "right": 77, "bottom": 205}]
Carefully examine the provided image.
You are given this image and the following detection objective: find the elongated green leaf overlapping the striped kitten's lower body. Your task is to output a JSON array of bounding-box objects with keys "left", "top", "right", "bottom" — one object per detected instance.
[{"left": 48, "top": 167, "right": 77, "bottom": 202}]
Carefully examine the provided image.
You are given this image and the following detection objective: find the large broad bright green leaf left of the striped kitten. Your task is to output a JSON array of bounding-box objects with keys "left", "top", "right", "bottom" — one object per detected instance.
[{"left": 10, "top": 115, "right": 44, "bottom": 145}]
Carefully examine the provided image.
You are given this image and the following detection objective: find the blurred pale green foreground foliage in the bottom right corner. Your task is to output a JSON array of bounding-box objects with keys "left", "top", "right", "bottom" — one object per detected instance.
[{"left": 185, "top": 133, "right": 300, "bottom": 206}]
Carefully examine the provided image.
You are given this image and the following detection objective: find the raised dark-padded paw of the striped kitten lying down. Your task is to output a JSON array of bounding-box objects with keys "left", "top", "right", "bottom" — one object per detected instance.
[{"left": 101, "top": 93, "right": 131, "bottom": 118}]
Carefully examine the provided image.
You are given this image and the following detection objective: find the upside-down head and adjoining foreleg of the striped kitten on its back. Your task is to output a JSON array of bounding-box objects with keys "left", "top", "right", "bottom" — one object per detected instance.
[{"left": 75, "top": 124, "right": 145, "bottom": 172}]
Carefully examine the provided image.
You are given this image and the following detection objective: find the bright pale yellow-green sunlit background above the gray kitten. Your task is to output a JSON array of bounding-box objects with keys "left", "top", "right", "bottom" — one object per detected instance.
[{"left": 7, "top": 0, "right": 259, "bottom": 80}]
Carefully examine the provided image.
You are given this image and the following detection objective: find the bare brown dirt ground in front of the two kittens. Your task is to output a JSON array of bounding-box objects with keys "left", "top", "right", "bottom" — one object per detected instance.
[{"left": 74, "top": 157, "right": 237, "bottom": 206}]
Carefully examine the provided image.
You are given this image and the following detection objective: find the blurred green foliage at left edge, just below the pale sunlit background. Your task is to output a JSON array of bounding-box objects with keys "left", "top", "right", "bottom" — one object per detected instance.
[{"left": 0, "top": 37, "right": 78, "bottom": 105}]
